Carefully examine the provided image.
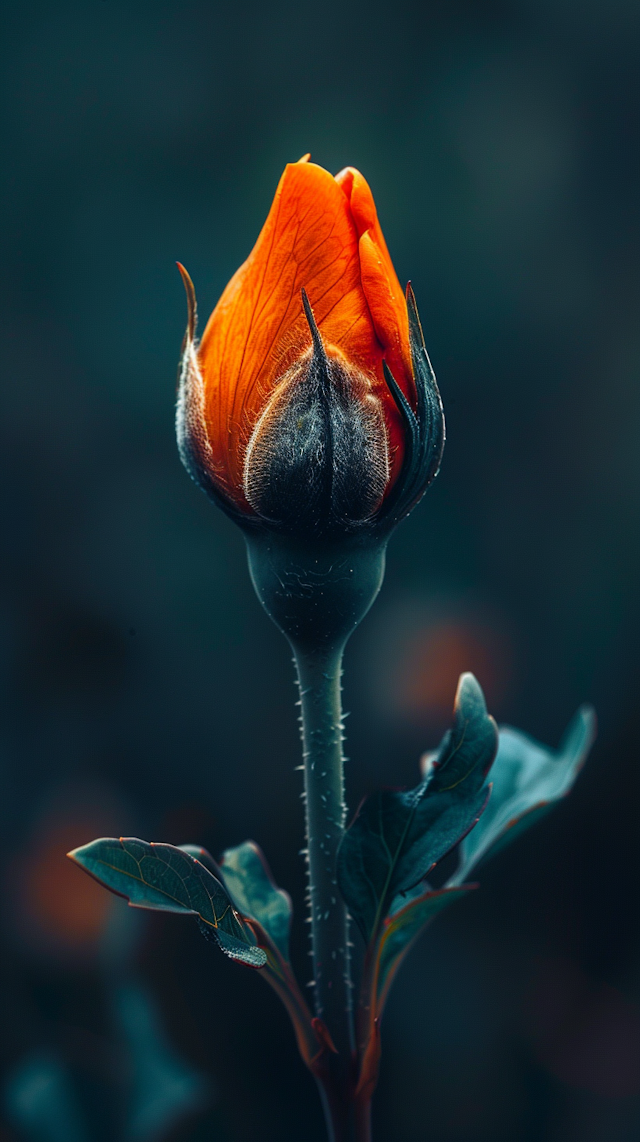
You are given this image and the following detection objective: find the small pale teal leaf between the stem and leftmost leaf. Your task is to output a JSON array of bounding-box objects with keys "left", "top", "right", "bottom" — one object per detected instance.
[{"left": 221, "top": 841, "right": 293, "bottom": 960}]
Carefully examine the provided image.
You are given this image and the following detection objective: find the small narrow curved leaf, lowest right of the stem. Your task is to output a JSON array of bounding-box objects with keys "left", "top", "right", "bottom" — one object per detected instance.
[{"left": 376, "top": 884, "right": 475, "bottom": 1015}]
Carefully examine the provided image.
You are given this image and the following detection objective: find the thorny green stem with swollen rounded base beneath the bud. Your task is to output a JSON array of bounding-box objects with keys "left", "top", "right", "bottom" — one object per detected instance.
[{"left": 247, "top": 530, "right": 386, "bottom": 1142}]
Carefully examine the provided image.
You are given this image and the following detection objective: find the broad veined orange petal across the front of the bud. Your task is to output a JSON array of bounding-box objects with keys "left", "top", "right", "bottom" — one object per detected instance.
[{"left": 199, "top": 161, "right": 382, "bottom": 488}]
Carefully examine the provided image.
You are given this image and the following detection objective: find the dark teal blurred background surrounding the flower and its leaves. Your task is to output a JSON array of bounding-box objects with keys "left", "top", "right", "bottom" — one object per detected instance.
[{"left": 0, "top": 0, "right": 640, "bottom": 1142}]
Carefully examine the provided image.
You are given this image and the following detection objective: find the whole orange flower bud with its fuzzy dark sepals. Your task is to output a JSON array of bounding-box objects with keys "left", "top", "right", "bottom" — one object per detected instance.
[{"left": 177, "top": 156, "right": 443, "bottom": 533}]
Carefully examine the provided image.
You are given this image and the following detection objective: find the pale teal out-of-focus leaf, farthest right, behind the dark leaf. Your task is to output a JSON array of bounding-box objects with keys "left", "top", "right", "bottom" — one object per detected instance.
[{"left": 448, "top": 706, "right": 595, "bottom": 885}]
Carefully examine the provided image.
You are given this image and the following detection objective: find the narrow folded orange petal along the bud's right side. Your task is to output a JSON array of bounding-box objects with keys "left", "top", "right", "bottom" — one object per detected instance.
[{"left": 336, "top": 167, "right": 415, "bottom": 402}]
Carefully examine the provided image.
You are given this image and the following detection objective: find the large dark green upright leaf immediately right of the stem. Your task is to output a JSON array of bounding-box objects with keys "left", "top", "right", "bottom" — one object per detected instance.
[{"left": 338, "top": 674, "right": 497, "bottom": 941}]
